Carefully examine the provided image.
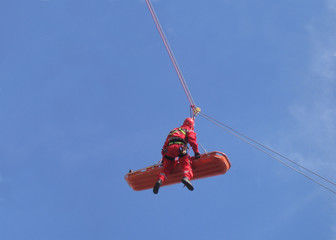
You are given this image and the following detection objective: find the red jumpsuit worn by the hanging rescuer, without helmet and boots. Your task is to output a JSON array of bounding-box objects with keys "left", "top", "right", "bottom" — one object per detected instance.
[{"left": 158, "top": 125, "right": 198, "bottom": 182}]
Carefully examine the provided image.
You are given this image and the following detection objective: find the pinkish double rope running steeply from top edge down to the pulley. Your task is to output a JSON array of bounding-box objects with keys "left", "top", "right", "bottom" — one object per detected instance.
[{"left": 146, "top": 0, "right": 195, "bottom": 108}]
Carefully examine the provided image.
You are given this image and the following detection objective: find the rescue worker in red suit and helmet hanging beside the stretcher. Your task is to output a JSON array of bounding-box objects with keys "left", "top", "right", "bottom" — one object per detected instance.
[{"left": 153, "top": 118, "right": 201, "bottom": 194}]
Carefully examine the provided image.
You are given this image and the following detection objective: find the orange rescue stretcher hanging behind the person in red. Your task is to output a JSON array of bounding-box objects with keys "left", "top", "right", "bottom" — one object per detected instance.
[{"left": 125, "top": 151, "right": 231, "bottom": 191}]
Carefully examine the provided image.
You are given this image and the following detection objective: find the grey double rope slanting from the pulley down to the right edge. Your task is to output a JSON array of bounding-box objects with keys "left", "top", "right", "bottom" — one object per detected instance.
[{"left": 199, "top": 113, "right": 336, "bottom": 195}]
